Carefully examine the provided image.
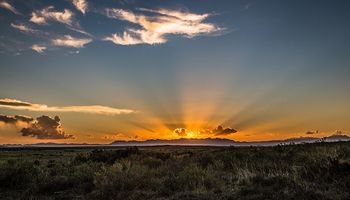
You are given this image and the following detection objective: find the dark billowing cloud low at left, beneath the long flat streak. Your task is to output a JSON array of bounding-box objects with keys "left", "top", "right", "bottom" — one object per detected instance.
[{"left": 21, "top": 115, "right": 74, "bottom": 139}]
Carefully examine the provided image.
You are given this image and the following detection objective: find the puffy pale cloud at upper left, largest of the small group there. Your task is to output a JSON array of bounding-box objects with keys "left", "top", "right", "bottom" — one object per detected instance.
[{"left": 29, "top": 6, "right": 74, "bottom": 25}]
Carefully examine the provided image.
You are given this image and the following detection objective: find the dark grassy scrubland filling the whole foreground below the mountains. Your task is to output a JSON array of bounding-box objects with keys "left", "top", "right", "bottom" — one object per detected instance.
[{"left": 0, "top": 142, "right": 350, "bottom": 199}]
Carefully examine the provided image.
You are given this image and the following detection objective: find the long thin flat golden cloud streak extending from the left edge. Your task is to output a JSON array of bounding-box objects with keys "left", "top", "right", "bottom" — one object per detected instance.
[{"left": 0, "top": 99, "right": 136, "bottom": 115}]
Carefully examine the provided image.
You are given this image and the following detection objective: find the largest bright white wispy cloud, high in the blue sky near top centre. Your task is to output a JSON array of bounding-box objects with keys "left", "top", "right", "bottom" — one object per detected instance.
[{"left": 104, "top": 8, "right": 222, "bottom": 45}]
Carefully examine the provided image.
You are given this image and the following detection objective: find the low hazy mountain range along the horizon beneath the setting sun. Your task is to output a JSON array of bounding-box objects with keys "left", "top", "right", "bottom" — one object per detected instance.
[{"left": 0, "top": 134, "right": 350, "bottom": 147}]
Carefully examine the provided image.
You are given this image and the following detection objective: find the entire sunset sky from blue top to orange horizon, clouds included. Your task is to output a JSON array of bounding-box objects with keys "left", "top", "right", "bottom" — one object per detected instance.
[{"left": 0, "top": 0, "right": 350, "bottom": 144}]
